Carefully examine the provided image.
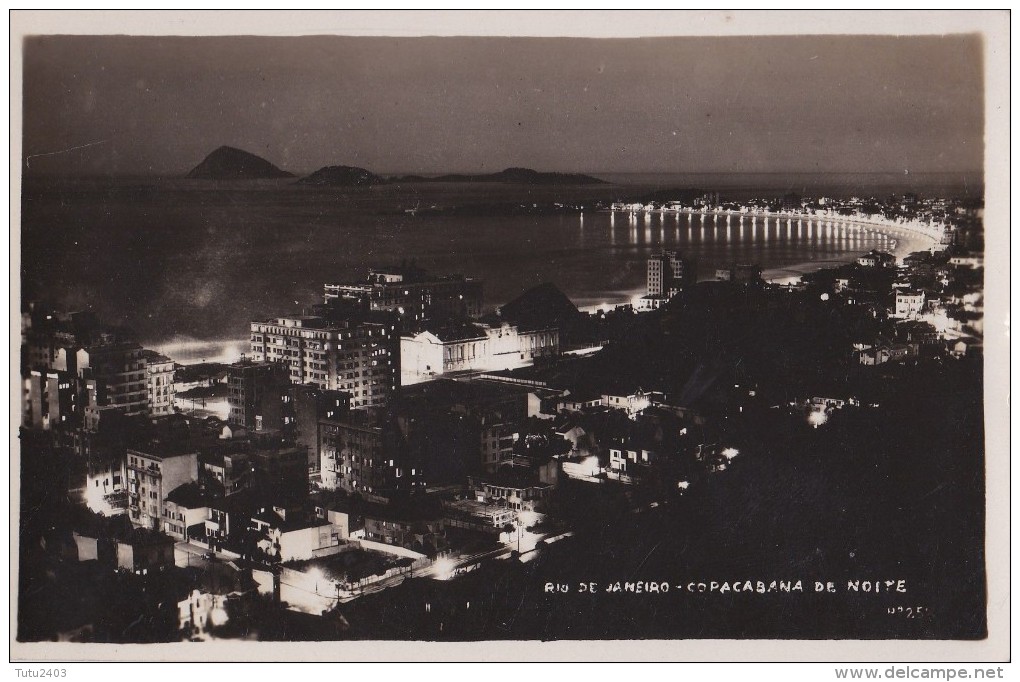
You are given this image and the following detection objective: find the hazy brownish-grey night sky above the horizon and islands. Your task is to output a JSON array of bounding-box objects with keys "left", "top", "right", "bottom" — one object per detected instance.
[{"left": 23, "top": 36, "right": 984, "bottom": 174}]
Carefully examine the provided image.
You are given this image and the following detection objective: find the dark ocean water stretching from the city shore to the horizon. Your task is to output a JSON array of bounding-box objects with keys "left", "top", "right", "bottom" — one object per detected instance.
[{"left": 20, "top": 173, "right": 982, "bottom": 362}]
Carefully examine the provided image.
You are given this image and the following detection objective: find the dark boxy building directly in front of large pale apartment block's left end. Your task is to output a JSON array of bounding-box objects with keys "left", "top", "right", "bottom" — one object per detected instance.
[{"left": 226, "top": 359, "right": 290, "bottom": 431}]
